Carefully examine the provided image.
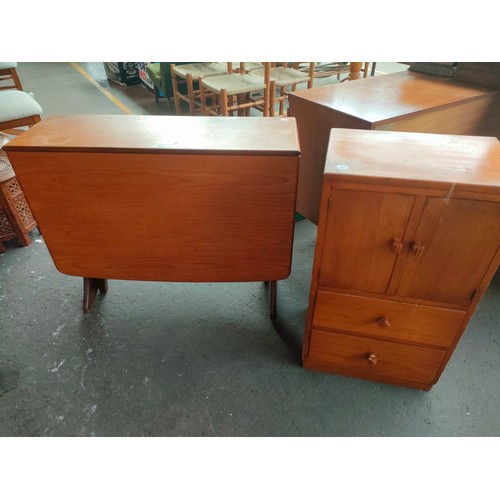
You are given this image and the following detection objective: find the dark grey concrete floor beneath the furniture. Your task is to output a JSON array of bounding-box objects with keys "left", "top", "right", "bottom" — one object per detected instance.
[{"left": 0, "top": 63, "right": 500, "bottom": 436}]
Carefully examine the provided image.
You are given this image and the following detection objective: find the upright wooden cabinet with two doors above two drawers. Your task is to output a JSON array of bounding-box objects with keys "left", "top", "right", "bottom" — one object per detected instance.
[{"left": 303, "top": 129, "right": 500, "bottom": 389}]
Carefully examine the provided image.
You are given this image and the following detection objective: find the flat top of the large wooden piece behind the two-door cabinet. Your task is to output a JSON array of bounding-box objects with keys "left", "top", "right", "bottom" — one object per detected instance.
[{"left": 290, "top": 70, "right": 497, "bottom": 123}]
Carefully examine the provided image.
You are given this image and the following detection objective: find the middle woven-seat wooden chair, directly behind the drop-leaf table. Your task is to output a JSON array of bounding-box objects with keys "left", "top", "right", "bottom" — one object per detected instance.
[{"left": 199, "top": 62, "right": 270, "bottom": 116}]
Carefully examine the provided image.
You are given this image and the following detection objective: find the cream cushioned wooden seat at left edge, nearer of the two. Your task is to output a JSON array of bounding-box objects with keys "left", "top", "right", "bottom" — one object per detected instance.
[{"left": 0, "top": 90, "right": 43, "bottom": 131}]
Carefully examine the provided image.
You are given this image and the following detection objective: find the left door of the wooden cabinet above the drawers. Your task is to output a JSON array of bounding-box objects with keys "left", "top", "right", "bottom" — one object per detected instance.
[{"left": 319, "top": 189, "right": 414, "bottom": 293}]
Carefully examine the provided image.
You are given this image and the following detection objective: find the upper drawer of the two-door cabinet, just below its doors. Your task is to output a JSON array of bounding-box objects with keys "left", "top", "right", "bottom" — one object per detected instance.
[{"left": 313, "top": 291, "right": 465, "bottom": 347}]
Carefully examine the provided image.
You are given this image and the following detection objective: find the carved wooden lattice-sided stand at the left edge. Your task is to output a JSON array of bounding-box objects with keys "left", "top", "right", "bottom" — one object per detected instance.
[{"left": 0, "top": 143, "right": 36, "bottom": 253}]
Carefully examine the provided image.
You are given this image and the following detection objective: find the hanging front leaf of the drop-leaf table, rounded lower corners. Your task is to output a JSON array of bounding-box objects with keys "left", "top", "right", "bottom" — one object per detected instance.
[{"left": 9, "top": 150, "right": 298, "bottom": 281}]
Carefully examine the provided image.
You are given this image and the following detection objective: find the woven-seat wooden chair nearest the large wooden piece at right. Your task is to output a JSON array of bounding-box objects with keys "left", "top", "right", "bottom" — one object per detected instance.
[{"left": 250, "top": 62, "right": 316, "bottom": 116}]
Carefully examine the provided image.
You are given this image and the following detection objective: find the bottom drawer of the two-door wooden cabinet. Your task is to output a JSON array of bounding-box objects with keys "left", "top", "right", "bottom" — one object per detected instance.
[{"left": 303, "top": 330, "right": 446, "bottom": 389}]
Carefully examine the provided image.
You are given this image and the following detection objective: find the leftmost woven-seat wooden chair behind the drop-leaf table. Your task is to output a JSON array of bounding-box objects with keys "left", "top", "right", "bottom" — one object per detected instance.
[{"left": 170, "top": 62, "right": 227, "bottom": 115}]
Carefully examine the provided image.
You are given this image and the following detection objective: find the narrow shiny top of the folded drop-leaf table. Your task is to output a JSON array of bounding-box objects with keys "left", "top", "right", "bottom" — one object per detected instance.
[{"left": 4, "top": 115, "right": 299, "bottom": 155}]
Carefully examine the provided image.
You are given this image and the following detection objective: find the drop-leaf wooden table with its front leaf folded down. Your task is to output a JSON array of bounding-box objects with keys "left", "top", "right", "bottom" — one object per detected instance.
[{"left": 5, "top": 115, "right": 299, "bottom": 312}]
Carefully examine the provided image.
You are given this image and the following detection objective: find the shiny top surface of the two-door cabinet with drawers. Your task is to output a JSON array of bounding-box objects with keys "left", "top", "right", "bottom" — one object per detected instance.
[{"left": 325, "top": 129, "right": 500, "bottom": 192}]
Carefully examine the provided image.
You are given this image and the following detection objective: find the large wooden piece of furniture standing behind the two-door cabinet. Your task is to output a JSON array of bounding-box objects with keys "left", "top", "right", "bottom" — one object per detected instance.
[{"left": 288, "top": 71, "right": 500, "bottom": 224}]
